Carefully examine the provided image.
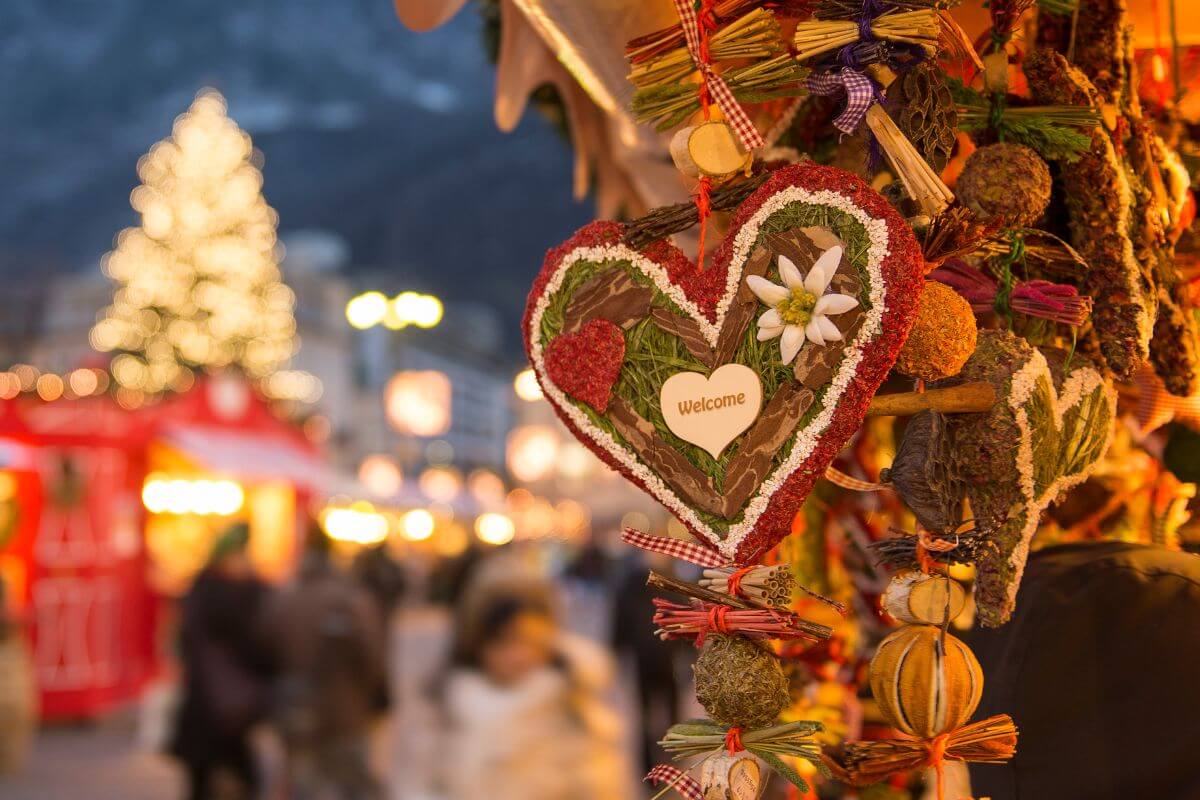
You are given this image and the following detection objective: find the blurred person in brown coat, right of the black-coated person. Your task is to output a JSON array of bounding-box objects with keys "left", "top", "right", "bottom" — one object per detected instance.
[{"left": 263, "top": 527, "right": 388, "bottom": 800}]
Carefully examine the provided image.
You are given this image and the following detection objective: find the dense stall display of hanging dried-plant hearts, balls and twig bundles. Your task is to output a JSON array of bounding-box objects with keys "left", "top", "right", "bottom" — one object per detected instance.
[{"left": 393, "top": 0, "right": 1200, "bottom": 800}]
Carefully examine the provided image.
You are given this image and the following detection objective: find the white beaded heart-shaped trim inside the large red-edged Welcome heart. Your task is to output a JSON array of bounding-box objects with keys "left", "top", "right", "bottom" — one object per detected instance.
[{"left": 528, "top": 186, "right": 889, "bottom": 559}]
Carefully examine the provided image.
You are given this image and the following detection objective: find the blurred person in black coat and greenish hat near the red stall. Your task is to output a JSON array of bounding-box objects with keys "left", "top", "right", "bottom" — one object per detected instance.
[{"left": 169, "top": 524, "right": 270, "bottom": 800}]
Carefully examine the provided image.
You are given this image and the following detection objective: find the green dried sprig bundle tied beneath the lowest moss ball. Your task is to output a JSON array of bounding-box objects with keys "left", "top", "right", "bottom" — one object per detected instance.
[{"left": 659, "top": 720, "right": 829, "bottom": 792}]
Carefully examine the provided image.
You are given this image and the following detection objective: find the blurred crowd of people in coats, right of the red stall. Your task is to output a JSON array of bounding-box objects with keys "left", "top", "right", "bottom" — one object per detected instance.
[{"left": 168, "top": 525, "right": 685, "bottom": 800}]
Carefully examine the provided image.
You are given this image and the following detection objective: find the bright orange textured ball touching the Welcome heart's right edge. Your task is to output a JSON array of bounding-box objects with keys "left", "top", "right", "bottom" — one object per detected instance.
[{"left": 895, "top": 281, "right": 977, "bottom": 380}]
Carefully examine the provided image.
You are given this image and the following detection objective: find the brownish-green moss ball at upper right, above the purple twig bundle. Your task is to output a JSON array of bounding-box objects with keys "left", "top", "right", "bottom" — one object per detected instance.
[{"left": 955, "top": 142, "right": 1050, "bottom": 225}]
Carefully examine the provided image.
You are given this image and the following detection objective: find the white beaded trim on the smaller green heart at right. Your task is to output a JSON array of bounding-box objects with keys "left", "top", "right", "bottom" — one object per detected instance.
[{"left": 1008, "top": 349, "right": 1116, "bottom": 604}]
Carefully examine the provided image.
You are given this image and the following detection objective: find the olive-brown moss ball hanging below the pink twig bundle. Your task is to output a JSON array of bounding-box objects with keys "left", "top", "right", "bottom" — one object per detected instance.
[{"left": 692, "top": 636, "right": 791, "bottom": 729}]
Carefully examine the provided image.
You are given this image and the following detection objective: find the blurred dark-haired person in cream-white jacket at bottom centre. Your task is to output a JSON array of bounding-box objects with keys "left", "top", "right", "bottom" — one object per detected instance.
[{"left": 442, "top": 596, "right": 630, "bottom": 800}]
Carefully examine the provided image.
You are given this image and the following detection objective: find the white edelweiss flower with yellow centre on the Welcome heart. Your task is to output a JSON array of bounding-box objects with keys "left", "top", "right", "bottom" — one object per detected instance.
[{"left": 746, "top": 247, "right": 858, "bottom": 363}]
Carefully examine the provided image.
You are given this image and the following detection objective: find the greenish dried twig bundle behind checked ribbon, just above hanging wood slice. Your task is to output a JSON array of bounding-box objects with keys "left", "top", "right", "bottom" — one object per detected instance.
[{"left": 631, "top": 53, "right": 809, "bottom": 131}]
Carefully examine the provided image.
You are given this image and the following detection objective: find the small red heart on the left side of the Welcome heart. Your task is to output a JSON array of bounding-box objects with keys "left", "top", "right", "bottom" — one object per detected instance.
[{"left": 545, "top": 319, "right": 625, "bottom": 414}]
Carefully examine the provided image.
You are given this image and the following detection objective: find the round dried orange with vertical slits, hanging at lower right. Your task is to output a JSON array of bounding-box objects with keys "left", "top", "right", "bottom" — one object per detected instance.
[{"left": 870, "top": 625, "right": 983, "bottom": 739}]
